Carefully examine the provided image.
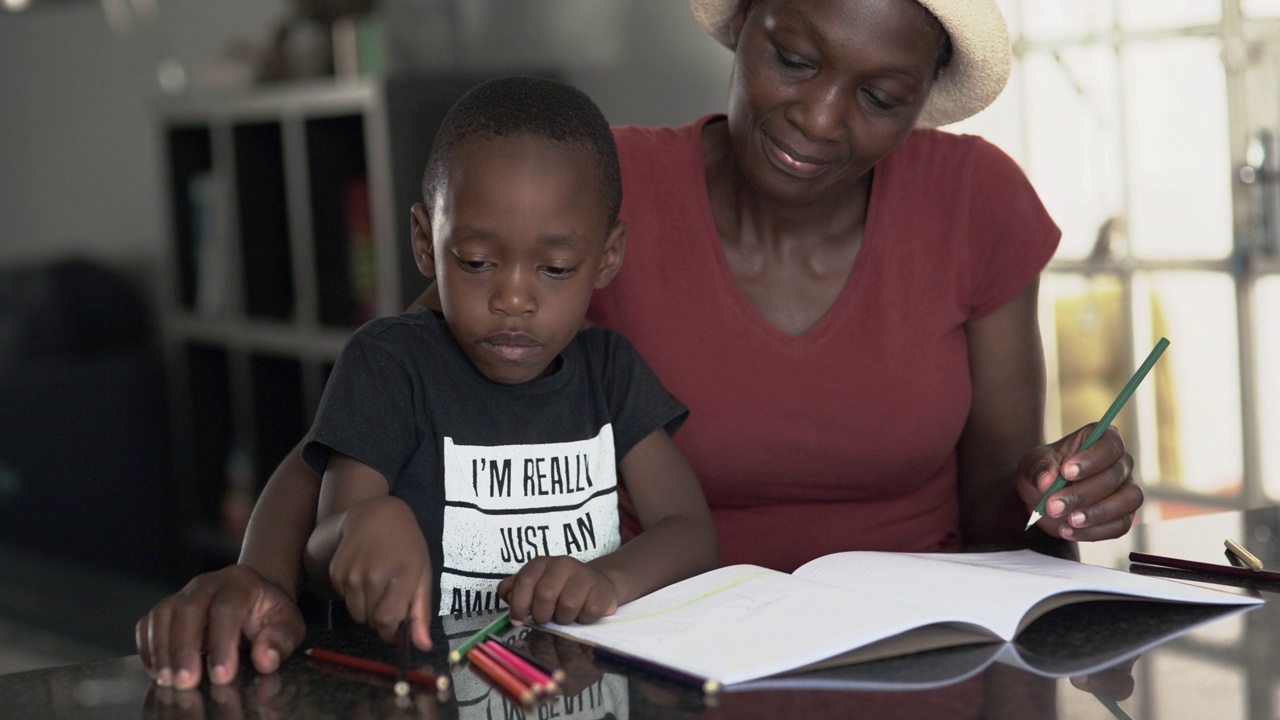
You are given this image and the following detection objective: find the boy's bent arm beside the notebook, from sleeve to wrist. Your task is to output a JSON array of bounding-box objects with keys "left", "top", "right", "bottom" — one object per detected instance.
[{"left": 589, "top": 428, "right": 719, "bottom": 603}]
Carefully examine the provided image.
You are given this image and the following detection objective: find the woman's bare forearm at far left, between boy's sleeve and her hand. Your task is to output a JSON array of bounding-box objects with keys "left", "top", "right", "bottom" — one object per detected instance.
[{"left": 239, "top": 443, "right": 320, "bottom": 597}]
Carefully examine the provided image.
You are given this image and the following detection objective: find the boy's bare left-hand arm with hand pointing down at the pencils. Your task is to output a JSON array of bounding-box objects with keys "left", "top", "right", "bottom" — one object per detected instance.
[{"left": 303, "top": 454, "right": 431, "bottom": 650}]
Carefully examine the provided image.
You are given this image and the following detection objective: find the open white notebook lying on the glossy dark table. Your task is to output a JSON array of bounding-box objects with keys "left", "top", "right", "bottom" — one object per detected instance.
[{"left": 543, "top": 550, "right": 1262, "bottom": 689}]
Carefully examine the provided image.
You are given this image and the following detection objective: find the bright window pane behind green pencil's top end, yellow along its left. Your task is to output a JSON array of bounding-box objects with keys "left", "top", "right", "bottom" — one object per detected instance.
[{"left": 1141, "top": 272, "right": 1243, "bottom": 496}]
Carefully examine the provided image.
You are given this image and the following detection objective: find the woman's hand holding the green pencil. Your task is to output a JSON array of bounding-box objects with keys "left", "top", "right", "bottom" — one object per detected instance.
[{"left": 1016, "top": 425, "right": 1143, "bottom": 541}]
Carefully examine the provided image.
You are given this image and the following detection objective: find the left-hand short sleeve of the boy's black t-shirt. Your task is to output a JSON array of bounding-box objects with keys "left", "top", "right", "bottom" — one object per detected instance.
[{"left": 302, "top": 327, "right": 417, "bottom": 484}]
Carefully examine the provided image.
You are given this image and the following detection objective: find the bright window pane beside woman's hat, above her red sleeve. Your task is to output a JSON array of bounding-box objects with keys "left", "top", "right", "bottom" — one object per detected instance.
[{"left": 1024, "top": 45, "right": 1124, "bottom": 258}]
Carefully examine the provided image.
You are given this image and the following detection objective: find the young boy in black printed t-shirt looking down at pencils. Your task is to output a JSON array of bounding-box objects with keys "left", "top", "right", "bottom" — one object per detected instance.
[{"left": 303, "top": 77, "right": 718, "bottom": 650}]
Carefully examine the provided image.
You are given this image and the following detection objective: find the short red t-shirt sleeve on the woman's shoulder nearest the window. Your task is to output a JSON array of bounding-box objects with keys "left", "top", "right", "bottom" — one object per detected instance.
[{"left": 969, "top": 138, "right": 1062, "bottom": 318}]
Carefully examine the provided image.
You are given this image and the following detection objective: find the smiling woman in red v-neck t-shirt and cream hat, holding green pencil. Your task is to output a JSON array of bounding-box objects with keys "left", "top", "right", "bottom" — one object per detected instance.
[{"left": 137, "top": 0, "right": 1142, "bottom": 687}]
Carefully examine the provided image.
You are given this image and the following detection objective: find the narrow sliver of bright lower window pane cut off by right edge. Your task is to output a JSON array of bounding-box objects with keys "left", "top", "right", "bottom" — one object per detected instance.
[{"left": 1253, "top": 277, "right": 1280, "bottom": 500}]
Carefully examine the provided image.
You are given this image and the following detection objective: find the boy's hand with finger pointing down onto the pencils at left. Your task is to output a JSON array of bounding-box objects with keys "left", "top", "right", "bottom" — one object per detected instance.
[{"left": 329, "top": 496, "right": 431, "bottom": 650}]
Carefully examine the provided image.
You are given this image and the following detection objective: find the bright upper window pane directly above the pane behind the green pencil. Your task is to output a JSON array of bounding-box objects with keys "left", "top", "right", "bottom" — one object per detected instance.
[{"left": 1123, "top": 38, "right": 1231, "bottom": 259}]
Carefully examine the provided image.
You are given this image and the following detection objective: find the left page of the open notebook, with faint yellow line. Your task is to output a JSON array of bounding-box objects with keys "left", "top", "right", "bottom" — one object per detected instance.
[{"left": 544, "top": 565, "right": 977, "bottom": 684}]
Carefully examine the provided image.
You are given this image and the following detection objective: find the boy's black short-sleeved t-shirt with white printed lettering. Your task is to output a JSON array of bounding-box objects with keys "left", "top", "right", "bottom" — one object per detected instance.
[{"left": 303, "top": 304, "right": 689, "bottom": 615}]
